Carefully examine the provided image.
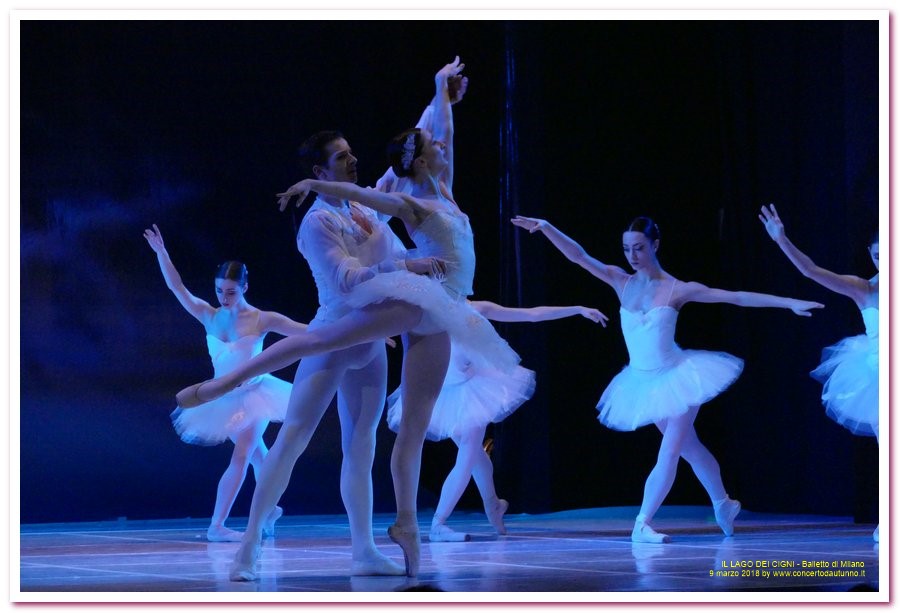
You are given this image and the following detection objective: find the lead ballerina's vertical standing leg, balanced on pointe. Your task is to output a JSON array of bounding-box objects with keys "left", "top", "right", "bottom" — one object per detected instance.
[{"left": 388, "top": 332, "right": 450, "bottom": 577}]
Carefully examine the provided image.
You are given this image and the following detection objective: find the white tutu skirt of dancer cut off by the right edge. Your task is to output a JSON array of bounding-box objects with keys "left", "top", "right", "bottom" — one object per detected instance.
[{"left": 810, "top": 334, "right": 878, "bottom": 436}]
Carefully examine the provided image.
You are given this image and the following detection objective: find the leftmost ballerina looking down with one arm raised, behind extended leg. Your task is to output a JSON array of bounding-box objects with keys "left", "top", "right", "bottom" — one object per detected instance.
[{"left": 144, "top": 224, "right": 306, "bottom": 542}]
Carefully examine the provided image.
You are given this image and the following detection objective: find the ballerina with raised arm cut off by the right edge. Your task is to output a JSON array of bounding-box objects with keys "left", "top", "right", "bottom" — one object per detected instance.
[{"left": 759, "top": 204, "right": 878, "bottom": 542}]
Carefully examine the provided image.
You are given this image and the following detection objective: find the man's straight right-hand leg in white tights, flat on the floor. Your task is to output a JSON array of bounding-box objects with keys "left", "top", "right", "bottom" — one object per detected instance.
[{"left": 338, "top": 346, "right": 405, "bottom": 575}]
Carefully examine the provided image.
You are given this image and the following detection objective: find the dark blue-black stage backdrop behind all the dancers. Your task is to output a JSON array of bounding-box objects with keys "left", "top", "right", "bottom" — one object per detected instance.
[{"left": 20, "top": 21, "right": 879, "bottom": 522}]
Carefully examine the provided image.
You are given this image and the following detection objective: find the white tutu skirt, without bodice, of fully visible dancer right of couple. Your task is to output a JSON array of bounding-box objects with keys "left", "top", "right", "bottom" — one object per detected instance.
[{"left": 597, "top": 347, "right": 744, "bottom": 430}]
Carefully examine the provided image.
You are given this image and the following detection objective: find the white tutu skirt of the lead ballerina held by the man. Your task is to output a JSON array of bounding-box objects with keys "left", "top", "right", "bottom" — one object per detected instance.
[{"left": 346, "top": 270, "right": 520, "bottom": 373}]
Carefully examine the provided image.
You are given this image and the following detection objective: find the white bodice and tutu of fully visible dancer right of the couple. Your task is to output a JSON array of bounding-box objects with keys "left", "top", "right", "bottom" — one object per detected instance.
[{"left": 597, "top": 306, "right": 744, "bottom": 430}]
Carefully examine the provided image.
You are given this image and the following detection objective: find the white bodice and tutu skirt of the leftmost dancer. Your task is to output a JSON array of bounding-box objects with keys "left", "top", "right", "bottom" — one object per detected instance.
[{"left": 171, "top": 335, "right": 292, "bottom": 445}]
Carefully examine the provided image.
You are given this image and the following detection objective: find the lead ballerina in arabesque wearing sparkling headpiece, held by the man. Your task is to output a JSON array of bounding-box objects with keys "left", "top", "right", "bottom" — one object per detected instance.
[{"left": 177, "top": 58, "right": 519, "bottom": 576}]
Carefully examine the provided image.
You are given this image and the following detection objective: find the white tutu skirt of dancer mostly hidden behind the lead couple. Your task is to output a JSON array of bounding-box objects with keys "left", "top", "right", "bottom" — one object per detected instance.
[{"left": 387, "top": 345, "right": 535, "bottom": 441}]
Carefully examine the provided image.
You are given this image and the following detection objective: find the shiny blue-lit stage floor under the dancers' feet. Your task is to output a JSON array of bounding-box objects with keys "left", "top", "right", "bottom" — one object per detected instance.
[{"left": 19, "top": 507, "right": 879, "bottom": 601}]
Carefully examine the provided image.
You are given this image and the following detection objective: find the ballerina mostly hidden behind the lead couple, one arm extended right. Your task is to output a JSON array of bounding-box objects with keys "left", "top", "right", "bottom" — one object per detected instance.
[{"left": 388, "top": 300, "right": 609, "bottom": 542}]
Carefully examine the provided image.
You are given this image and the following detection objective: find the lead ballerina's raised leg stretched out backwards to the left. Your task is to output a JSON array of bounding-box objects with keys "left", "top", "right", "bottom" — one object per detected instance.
[{"left": 181, "top": 301, "right": 422, "bottom": 408}]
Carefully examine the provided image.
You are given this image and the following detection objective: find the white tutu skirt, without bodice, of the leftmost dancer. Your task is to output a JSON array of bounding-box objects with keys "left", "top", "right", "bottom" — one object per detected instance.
[{"left": 171, "top": 375, "right": 291, "bottom": 445}]
